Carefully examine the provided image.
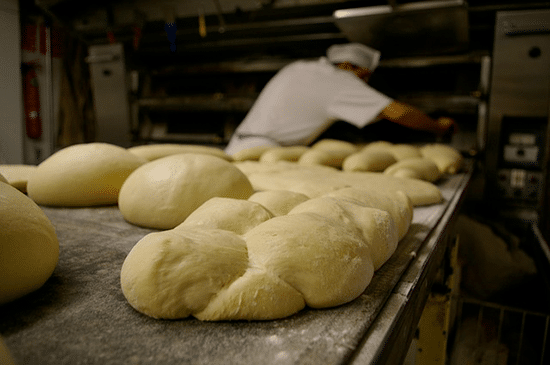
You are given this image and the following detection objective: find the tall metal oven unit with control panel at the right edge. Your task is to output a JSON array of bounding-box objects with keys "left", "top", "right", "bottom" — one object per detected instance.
[{"left": 486, "top": 9, "right": 550, "bottom": 214}]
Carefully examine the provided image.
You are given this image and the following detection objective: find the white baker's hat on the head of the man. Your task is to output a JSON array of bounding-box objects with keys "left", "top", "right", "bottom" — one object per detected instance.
[{"left": 327, "top": 43, "right": 380, "bottom": 71}]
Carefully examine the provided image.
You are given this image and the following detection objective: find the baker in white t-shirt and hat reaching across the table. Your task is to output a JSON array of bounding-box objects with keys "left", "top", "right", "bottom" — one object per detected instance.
[{"left": 225, "top": 43, "right": 455, "bottom": 155}]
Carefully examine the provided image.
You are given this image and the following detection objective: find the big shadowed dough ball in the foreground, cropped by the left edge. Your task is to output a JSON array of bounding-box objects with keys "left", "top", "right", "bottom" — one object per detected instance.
[{"left": 0, "top": 183, "right": 59, "bottom": 304}]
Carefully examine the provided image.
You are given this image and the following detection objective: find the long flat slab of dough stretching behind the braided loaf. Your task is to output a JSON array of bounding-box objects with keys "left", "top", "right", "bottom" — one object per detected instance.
[{"left": 235, "top": 161, "right": 442, "bottom": 206}]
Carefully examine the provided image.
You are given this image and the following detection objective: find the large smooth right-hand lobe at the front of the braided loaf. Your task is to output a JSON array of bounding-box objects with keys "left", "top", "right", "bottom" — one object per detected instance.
[{"left": 244, "top": 213, "right": 374, "bottom": 308}]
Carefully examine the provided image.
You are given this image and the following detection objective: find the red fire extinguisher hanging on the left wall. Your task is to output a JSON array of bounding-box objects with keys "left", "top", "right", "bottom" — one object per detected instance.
[{"left": 23, "top": 64, "right": 42, "bottom": 139}]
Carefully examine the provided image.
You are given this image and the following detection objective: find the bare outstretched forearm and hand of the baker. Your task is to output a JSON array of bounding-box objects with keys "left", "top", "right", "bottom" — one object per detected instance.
[{"left": 379, "top": 101, "right": 456, "bottom": 135}]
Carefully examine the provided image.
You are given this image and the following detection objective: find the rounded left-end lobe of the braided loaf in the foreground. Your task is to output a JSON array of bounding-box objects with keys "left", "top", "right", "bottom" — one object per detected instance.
[{"left": 120, "top": 229, "right": 248, "bottom": 318}]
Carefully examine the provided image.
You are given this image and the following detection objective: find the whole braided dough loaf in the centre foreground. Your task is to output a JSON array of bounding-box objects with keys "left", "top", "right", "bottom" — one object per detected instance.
[{"left": 121, "top": 189, "right": 412, "bottom": 321}]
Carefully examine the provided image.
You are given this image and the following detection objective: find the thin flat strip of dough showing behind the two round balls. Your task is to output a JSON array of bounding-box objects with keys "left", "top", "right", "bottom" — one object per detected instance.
[{"left": 128, "top": 143, "right": 233, "bottom": 161}]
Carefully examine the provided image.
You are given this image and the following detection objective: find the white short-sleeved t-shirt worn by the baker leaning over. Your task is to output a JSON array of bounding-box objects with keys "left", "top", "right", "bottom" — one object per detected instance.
[{"left": 225, "top": 57, "right": 392, "bottom": 154}]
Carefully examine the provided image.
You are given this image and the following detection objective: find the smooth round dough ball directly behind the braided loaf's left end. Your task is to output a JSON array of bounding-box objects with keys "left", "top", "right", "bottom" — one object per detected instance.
[{"left": 118, "top": 153, "right": 254, "bottom": 229}]
